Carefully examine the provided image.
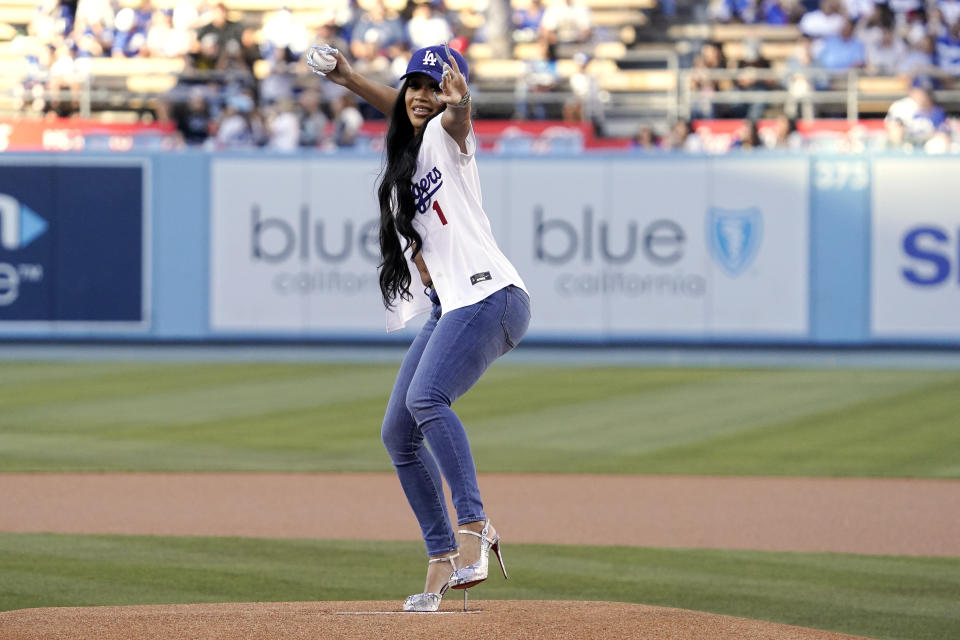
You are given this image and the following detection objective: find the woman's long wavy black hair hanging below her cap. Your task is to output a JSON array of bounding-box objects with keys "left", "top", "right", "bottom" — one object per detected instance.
[{"left": 377, "top": 79, "right": 442, "bottom": 308}]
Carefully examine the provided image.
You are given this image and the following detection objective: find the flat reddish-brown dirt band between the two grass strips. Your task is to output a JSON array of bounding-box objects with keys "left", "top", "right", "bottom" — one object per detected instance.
[{"left": 0, "top": 473, "right": 960, "bottom": 556}]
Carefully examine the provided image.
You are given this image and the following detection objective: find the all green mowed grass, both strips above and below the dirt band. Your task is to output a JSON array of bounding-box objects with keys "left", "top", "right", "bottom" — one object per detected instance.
[{"left": 0, "top": 362, "right": 960, "bottom": 640}]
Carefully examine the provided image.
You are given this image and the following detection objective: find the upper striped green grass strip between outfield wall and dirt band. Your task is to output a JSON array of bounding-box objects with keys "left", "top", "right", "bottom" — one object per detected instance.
[{"left": 0, "top": 363, "right": 960, "bottom": 477}]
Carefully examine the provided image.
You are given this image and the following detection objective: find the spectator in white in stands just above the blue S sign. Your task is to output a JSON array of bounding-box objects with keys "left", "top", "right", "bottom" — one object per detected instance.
[{"left": 884, "top": 76, "right": 949, "bottom": 149}]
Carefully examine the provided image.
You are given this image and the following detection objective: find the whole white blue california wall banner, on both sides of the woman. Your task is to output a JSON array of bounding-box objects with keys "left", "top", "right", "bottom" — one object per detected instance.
[{"left": 210, "top": 157, "right": 809, "bottom": 339}]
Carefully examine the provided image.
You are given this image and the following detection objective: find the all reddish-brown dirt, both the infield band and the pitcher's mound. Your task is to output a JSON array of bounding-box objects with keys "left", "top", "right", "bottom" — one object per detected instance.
[{"left": 0, "top": 473, "right": 960, "bottom": 640}]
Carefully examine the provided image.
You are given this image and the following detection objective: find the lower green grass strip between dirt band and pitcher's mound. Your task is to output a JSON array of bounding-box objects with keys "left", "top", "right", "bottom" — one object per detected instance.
[{"left": 0, "top": 534, "right": 960, "bottom": 640}]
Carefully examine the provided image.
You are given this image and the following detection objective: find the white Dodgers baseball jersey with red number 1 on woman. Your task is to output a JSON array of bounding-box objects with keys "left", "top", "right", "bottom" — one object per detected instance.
[{"left": 387, "top": 115, "right": 526, "bottom": 331}]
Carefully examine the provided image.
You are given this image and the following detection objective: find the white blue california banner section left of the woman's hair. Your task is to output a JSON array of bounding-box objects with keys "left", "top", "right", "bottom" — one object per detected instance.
[{"left": 210, "top": 158, "right": 384, "bottom": 334}]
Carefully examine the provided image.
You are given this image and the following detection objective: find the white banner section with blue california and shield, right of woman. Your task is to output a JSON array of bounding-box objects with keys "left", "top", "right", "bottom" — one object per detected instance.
[{"left": 507, "top": 158, "right": 809, "bottom": 338}]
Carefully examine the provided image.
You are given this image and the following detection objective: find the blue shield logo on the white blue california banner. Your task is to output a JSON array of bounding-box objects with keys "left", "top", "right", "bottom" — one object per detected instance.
[{"left": 707, "top": 207, "right": 763, "bottom": 278}]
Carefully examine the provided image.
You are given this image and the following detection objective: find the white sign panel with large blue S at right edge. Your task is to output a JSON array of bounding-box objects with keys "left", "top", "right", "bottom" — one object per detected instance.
[{"left": 870, "top": 158, "right": 960, "bottom": 338}]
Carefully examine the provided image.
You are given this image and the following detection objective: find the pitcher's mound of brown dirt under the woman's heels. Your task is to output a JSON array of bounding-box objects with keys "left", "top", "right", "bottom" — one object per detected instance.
[{"left": 0, "top": 598, "right": 872, "bottom": 640}]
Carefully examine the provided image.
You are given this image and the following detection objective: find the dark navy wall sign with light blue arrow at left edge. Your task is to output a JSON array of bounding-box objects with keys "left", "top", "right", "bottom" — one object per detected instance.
[{"left": 0, "top": 165, "right": 144, "bottom": 323}]
